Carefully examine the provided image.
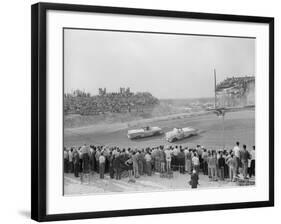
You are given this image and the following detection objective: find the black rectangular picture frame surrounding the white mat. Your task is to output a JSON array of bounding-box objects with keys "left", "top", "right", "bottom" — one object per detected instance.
[{"left": 31, "top": 3, "right": 274, "bottom": 221}]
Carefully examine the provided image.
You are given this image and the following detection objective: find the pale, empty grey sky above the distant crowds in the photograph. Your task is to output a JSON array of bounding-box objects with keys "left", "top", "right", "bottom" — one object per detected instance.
[{"left": 64, "top": 29, "right": 255, "bottom": 99}]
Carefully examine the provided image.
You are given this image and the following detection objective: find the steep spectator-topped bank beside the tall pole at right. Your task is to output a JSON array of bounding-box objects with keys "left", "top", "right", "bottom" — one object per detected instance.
[{"left": 216, "top": 76, "right": 255, "bottom": 107}]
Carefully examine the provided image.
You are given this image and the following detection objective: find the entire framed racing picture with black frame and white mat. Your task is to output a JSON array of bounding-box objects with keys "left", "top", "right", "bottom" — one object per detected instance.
[{"left": 31, "top": 3, "right": 274, "bottom": 221}]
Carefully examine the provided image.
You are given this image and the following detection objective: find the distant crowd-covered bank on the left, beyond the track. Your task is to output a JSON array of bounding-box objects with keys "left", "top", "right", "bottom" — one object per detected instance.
[{"left": 64, "top": 88, "right": 159, "bottom": 115}]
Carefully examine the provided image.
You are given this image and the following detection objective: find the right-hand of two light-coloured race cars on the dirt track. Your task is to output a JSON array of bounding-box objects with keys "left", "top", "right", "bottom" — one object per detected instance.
[{"left": 166, "top": 127, "right": 198, "bottom": 142}]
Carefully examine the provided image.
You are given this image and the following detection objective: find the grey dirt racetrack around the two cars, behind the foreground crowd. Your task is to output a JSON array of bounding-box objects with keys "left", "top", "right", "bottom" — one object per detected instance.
[{"left": 64, "top": 110, "right": 255, "bottom": 149}]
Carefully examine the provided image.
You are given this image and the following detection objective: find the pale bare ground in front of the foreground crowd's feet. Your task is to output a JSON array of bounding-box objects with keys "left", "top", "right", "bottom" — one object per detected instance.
[{"left": 64, "top": 172, "right": 243, "bottom": 195}]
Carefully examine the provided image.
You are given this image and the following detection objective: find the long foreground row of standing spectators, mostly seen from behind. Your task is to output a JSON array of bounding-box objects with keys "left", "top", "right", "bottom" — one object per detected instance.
[{"left": 64, "top": 142, "right": 255, "bottom": 187}]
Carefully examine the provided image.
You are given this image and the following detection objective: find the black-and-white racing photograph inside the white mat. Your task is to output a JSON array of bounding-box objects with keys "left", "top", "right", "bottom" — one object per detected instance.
[{"left": 62, "top": 27, "right": 256, "bottom": 196}]
